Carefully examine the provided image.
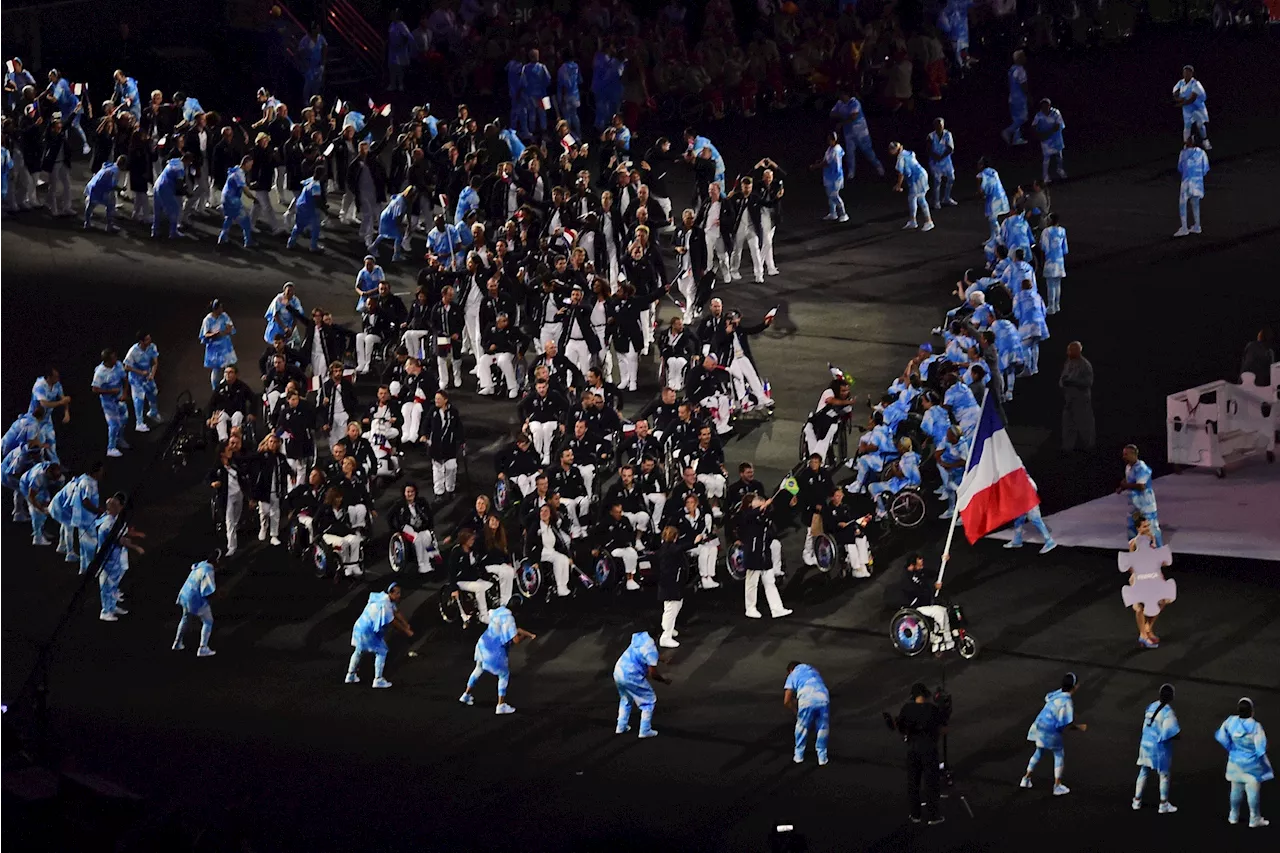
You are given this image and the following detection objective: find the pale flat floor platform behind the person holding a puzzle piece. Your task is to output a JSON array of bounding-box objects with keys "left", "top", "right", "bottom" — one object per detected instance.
[{"left": 988, "top": 461, "right": 1280, "bottom": 560}]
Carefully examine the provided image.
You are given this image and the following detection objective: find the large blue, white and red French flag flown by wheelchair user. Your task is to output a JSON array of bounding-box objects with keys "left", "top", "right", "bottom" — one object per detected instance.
[{"left": 956, "top": 391, "right": 1039, "bottom": 544}]
